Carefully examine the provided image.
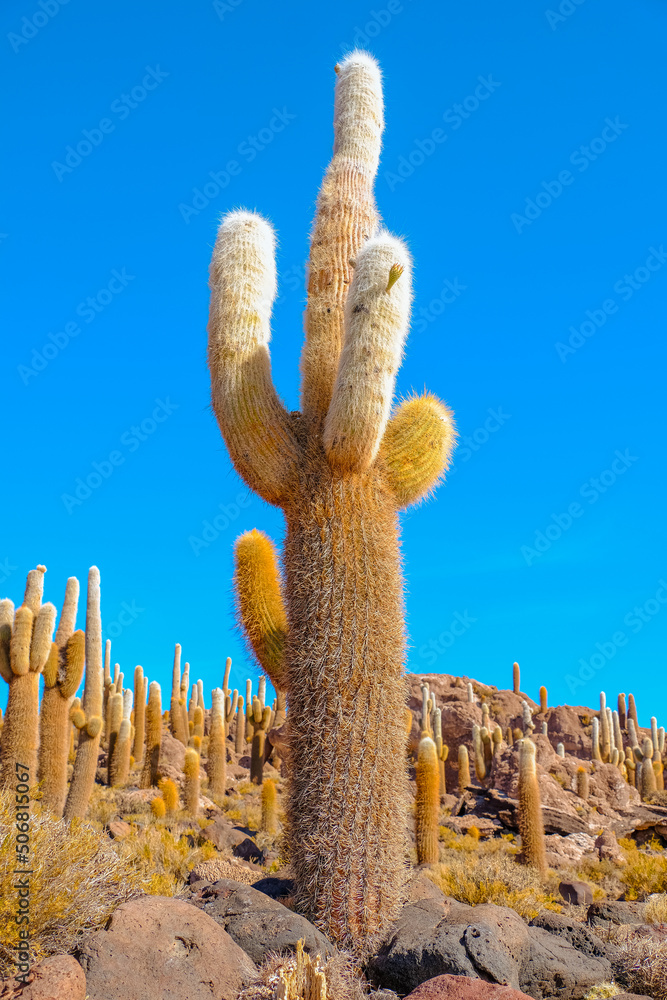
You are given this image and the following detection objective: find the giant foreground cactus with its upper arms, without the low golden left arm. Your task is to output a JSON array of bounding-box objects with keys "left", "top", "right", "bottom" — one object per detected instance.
[{"left": 209, "top": 53, "right": 454, "bottom": 950}]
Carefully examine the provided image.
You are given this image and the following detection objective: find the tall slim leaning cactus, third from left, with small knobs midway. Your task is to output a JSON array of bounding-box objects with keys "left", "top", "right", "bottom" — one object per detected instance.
[{"left": 64, "top": 566, "right": 104, "bottom": 822}]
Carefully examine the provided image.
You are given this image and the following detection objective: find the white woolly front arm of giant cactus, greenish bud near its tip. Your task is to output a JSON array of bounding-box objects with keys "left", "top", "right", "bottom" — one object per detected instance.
[{"left": 324, "top": 233, "right": 411, "bottom": 472}]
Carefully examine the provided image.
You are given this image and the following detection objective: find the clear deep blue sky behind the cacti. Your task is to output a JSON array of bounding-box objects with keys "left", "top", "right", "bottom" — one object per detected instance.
[{"left": 0, "top": 0, "right": 667, "bottom": 724}]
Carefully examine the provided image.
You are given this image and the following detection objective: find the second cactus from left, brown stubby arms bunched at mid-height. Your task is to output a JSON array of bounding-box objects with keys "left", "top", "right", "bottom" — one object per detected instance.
[{"left": 39, "top": 576, "right": 85, "bottom": 817}]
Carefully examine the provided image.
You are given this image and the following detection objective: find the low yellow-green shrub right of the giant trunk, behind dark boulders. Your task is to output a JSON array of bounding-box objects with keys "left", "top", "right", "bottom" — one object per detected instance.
[{"left": 427, "top": 842, "right": 562, "bottom": 919}]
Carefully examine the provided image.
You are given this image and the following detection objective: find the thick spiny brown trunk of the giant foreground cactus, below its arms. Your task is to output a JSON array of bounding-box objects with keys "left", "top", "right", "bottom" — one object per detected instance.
[{"left": 284, "top": 454, "right": 406, "bottom": 944}]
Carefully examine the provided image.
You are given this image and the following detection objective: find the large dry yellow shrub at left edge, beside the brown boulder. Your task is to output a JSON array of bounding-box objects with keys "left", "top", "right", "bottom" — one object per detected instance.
[{"left": 0, "top": 793, "right": 151, "bottom": 978}]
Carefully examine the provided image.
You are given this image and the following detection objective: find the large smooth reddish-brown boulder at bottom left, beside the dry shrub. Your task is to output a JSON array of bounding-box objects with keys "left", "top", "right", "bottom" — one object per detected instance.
[{"left": 79, "top": 896, "right": 257, "bottom": 1000}]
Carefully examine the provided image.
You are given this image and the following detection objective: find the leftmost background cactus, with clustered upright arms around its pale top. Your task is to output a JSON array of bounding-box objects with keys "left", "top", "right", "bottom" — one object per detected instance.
[{"left": 0, "top": 566, "right": 56, "bottom": 789}]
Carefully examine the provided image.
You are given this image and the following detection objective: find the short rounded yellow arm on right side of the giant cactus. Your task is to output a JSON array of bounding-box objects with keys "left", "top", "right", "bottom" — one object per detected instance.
[{"left": 382, "top": 393, "right": 456, "bottom": 508}]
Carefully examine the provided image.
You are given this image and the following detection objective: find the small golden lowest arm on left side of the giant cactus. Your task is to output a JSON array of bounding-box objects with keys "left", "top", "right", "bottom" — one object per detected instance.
[{"left": 234, "top": 528, "right": 287, "bottom": 690}]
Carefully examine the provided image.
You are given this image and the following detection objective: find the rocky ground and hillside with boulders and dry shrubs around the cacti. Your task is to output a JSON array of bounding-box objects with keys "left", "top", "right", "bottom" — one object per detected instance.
[{"left": 0, "top": 675, "right": 667, "bottom": 1000}]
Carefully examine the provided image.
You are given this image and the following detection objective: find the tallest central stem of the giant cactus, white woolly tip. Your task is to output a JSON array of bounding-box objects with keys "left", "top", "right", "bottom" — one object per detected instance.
[{"left": 301, "top": 52, "right": 384, "bottom": 423}]
